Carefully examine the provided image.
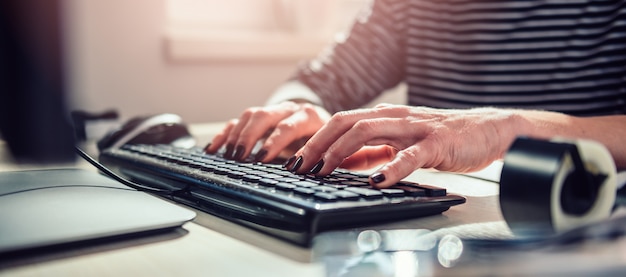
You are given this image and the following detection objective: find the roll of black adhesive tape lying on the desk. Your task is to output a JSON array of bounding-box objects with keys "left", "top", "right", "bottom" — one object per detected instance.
[{"left": 500, "top": 137, "right": 616, "bottom": 237}]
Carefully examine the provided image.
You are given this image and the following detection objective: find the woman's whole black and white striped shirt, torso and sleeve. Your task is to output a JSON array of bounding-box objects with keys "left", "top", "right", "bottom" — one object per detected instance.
[{"left": 294, "top": 0, "right": 626, "bottom": 116}]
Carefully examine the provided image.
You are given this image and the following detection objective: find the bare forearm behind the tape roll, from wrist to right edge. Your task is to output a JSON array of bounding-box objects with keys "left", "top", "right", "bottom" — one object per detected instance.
[{"left": 512, "top": 110, "right": 626, "bottom": 169}]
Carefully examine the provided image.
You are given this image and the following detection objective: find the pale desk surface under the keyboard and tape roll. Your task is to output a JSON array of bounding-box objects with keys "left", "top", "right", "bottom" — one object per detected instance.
[{"left": 0, "top": 124, "right": 626, "bottom": 277}]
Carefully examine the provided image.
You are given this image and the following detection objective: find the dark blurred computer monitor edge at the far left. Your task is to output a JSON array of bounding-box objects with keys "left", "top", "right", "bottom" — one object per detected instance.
[{"left": 0, "top": 0, "right": 75, "bottom": 163}]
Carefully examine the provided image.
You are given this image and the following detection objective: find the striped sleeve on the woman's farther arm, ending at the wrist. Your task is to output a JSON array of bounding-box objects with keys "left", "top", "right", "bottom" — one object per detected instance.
[{"left": 286, "top": 0, "right": 407, "bottom": 113}]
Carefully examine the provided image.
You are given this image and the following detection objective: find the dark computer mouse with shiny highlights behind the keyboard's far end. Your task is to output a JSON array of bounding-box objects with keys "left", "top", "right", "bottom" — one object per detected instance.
[{"left": 97, "top": 113, "right": 196, "bottom": 151}]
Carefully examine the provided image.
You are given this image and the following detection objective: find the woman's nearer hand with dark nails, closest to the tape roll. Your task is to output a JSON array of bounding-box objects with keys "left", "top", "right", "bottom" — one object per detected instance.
[{"left": 287, "top": 105, "right": 521, "bottom": 188}]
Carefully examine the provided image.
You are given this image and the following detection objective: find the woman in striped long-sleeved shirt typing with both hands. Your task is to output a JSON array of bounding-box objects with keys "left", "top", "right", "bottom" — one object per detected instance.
[{"left": 206, "top": 0, "right": 626, "bottom": 188}]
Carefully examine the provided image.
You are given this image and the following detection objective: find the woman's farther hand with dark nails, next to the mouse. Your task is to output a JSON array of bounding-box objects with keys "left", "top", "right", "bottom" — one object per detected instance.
[{"left": 205, "top": 101, "right": 330, "bottom": 162}]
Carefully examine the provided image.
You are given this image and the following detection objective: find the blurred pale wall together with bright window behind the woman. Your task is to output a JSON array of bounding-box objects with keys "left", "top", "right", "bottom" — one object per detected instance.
[{"left": 64, "top": 0, "right": 404, "bottom": 123}]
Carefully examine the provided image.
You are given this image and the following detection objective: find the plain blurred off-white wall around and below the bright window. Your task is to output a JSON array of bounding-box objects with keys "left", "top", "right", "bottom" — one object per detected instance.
[{"left": 67, "top": 0, "right": 398, "bottom": 123}]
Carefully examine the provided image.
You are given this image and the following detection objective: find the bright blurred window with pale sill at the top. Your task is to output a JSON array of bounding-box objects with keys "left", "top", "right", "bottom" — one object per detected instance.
[{"left": 165, "top": 0, "right": 367, "bottom": 62}]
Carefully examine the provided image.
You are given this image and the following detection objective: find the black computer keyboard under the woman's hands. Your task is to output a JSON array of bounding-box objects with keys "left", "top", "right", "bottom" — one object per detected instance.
[{"left": 100, "top": 145, "right": 465, "bottom": 246}]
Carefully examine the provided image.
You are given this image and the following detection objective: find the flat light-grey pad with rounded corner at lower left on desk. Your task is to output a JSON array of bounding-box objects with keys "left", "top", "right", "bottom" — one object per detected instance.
[{"left": 0, "top": 169, "right": 196, "bottom": 254}]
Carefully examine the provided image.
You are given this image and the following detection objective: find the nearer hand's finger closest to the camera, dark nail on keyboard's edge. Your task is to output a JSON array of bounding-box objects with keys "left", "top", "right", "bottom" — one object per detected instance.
[{"left": 370, "top": 146, "right": 428, "bottom": 189}]
